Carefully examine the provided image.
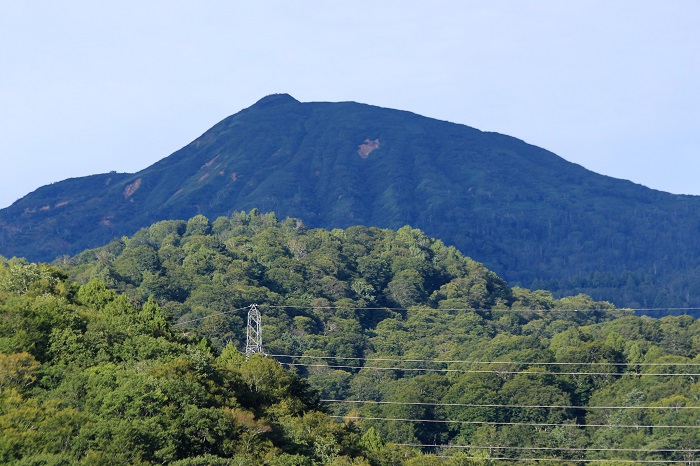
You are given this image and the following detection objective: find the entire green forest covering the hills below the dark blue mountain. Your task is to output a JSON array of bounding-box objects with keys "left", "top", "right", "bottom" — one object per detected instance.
[{"left": 0, "top": 210, "right": 700, "bottom": 466}]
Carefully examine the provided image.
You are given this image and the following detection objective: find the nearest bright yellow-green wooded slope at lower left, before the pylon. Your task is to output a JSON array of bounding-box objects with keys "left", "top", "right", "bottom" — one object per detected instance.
[{"left": 0, "top": 264, "right": 368, "bottom": 465}]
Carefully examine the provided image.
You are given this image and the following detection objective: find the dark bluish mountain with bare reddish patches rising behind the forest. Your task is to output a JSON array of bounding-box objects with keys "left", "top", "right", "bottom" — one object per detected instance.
[{"left": 0, "top": 94, "right": 700, "bottom": 307}]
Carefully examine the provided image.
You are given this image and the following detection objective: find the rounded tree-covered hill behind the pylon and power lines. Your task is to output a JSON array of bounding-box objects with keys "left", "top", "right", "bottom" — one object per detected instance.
[{"left": 19, "top": 211, "right": 700, "bottom": 464}]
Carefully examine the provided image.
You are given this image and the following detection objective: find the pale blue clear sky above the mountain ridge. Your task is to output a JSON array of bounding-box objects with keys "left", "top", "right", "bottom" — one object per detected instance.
[{"left": 0, "top": 0, "right": 700, "bottom": 207}]
